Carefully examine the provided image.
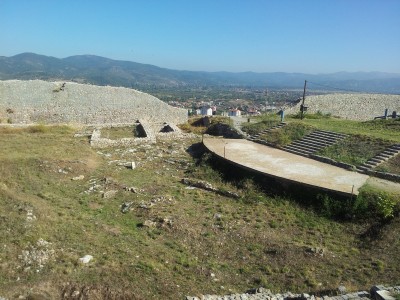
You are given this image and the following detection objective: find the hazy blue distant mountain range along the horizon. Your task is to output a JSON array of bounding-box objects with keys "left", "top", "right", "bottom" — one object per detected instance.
[{"left": 0, "top": 53, "right": 400, "bottom": 94}]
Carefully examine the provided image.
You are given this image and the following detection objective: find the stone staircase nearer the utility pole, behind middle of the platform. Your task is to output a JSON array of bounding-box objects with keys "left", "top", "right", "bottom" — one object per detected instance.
[{"left": 283, "top": 130, "right": 347, "bottom": 157}]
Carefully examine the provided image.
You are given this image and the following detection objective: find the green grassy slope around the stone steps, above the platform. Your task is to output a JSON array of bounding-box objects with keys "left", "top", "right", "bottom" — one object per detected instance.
[{"left": 243, "top": 113, "right": 400, "bottom": 170}]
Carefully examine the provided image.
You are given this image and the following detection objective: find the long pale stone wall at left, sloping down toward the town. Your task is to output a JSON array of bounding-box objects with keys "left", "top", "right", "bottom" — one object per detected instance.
[{"left": 0, "top": 80, "right": 187, "bottom": 124}]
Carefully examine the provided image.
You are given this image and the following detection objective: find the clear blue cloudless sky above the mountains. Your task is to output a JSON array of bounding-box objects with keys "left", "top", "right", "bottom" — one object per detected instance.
[{"left": 0, "top": 0, "right": 400, "bottom": 74}]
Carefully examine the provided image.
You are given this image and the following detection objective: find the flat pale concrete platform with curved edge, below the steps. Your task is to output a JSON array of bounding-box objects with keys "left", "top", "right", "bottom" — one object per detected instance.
[{"left": 203, "top": 138, "right": 369, "bottom": 195}]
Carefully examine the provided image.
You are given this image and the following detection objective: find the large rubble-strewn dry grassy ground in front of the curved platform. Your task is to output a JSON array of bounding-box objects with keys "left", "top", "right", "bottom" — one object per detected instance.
[{"left": 0, "top": 125, "right": 400, "bottom": 299}]
